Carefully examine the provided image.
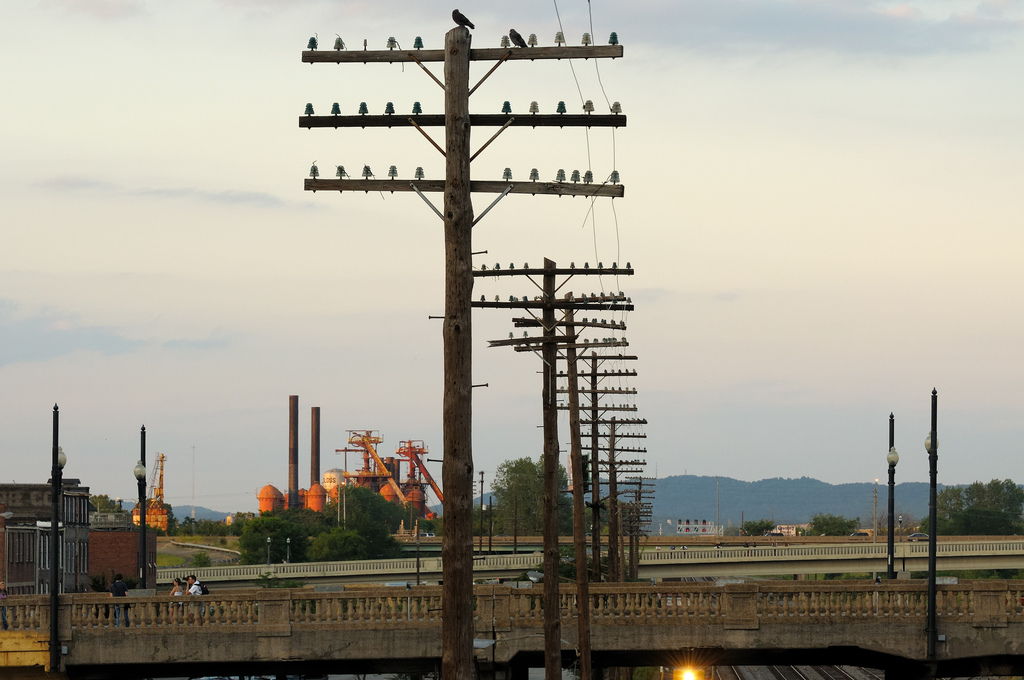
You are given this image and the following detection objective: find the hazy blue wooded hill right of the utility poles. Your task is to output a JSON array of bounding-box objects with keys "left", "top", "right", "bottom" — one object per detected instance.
[{"left": 652, "top": 475, "right": 942, "bottom": 530}]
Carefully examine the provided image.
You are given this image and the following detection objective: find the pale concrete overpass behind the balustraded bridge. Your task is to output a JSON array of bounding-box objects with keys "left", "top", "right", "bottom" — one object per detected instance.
[{"left": 157, "top": 539, "right": 1024, "bottom": 589}]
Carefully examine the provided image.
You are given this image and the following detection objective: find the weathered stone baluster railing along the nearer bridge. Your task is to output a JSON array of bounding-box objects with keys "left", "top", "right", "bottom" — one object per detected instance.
[{"left": 4, "top": 581, "right": 1024, "bottom": 635}]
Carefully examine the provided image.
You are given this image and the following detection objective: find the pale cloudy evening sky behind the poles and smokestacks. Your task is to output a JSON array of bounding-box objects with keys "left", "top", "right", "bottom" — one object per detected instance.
[{"left": 0, "top": 0, "right": 1024, "bottom": 511}]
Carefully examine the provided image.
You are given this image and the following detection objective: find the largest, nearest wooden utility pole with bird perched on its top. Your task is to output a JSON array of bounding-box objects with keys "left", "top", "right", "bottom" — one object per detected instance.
[{"left": 299, "top": 27, "right": 626, "bottom": 680}]
